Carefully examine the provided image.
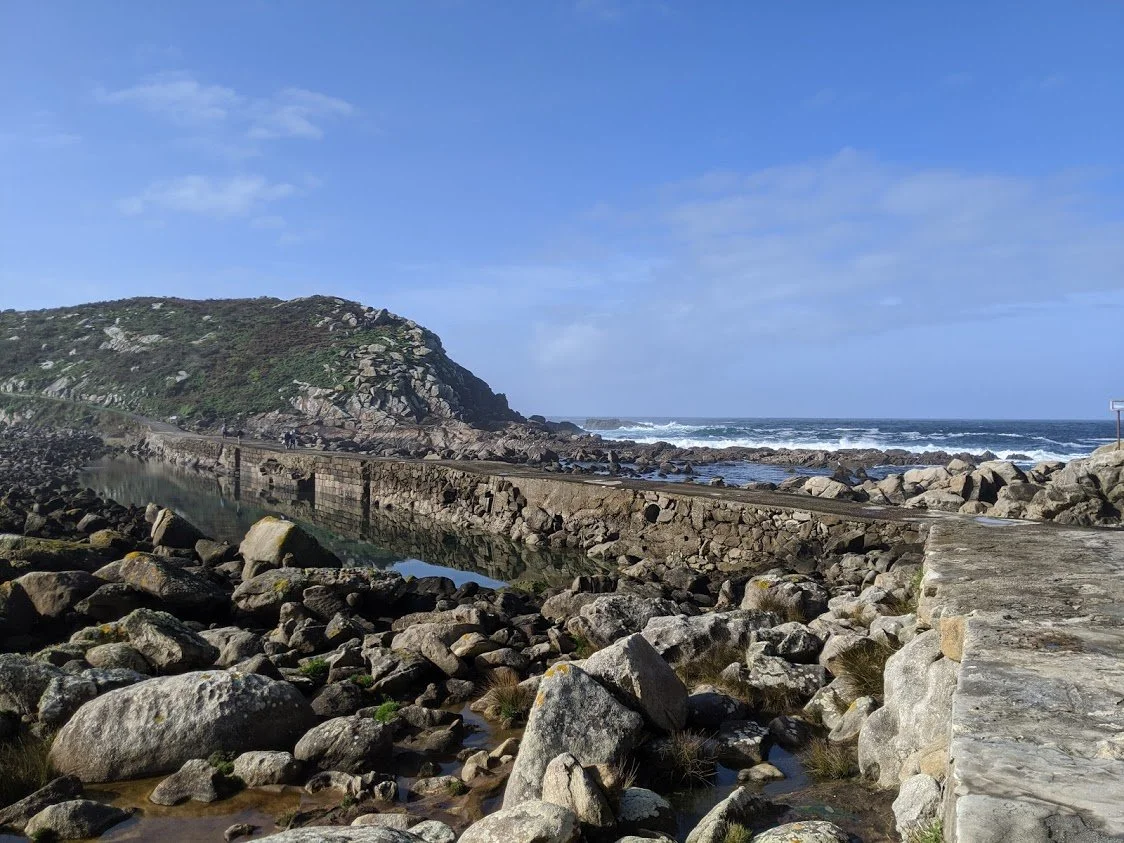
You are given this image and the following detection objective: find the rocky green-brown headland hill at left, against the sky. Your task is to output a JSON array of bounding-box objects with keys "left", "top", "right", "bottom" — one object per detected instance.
[{"left": 0, "top": 296, "right": 520, "bottom": 430}]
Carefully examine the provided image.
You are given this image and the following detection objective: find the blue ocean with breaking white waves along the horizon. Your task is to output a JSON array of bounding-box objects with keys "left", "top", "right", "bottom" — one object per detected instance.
[{"left": 565, "top": 416, "right": 1116, "bottom": 463}]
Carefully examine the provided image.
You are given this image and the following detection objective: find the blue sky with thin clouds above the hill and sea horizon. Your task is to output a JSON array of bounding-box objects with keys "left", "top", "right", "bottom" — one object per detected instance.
[{"left": 0, "top": 0, "right": 1124, "bottom": 418}]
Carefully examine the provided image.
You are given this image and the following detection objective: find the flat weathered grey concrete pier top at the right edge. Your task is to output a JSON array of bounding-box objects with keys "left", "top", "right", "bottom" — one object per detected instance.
[{"left": 921, "top": 517, "right": 1124, "bottom": 843}]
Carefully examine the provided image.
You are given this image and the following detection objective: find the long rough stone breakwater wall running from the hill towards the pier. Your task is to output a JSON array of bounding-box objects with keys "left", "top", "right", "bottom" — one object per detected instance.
[{"left": 144, "top": 434, "right": 927, "bottom": 571}]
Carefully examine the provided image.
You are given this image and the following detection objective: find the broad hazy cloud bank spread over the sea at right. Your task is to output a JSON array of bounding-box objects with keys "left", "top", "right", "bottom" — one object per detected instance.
[{"left": 382, "top": 149, "right": 1124, "bottom": 407}]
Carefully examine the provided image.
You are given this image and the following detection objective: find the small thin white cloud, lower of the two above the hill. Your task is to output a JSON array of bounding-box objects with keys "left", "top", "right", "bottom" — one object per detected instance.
[{"left": 117, "top": 175, "right": 297, "bottom": 219}]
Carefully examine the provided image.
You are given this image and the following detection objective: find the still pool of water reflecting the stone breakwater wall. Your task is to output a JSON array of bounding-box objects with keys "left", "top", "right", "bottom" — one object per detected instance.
[{"left": 84, "top": 459, "right": 597, "bottom": 582}]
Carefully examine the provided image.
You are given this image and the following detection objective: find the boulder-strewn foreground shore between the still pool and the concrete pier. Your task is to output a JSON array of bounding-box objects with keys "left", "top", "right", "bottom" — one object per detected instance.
[{"left": 0, "top": 429, "right": 932, "bottom": 843}]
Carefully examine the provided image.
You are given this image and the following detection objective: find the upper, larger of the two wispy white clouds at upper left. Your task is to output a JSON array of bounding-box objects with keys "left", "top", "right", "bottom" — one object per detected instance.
[{"left": 94, "top": 71, "right": 356, "bottom": 141}]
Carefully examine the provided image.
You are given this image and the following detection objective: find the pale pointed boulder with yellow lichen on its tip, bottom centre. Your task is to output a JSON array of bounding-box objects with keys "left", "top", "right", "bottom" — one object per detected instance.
[{"left": 504, "top": 663, "right": 643, "bottom": 808}]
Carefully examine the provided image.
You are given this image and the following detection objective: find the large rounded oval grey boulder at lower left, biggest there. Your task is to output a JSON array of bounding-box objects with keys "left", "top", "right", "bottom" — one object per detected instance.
[{"left": 51, "top": 671, "right": 312, "bottom": 781}]
